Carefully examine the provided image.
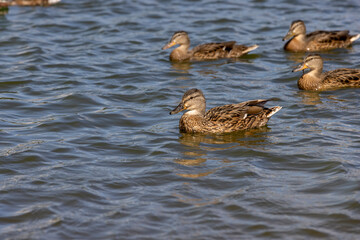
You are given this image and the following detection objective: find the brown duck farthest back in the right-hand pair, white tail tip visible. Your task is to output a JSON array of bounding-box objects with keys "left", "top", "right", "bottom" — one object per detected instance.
[{"left": 283, "top": 20, "right": 360, "bottom": 52}]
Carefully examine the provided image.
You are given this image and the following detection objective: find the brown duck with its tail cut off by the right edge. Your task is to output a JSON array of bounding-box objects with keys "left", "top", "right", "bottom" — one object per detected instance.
[{"left": 292, "top": 54, "right": 360, "bottom": 91}]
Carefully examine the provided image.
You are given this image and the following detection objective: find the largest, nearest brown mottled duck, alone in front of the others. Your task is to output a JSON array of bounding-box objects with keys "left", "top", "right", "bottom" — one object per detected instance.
[{"left": 170, "top": 88, "right": 282, "bottom": 134}]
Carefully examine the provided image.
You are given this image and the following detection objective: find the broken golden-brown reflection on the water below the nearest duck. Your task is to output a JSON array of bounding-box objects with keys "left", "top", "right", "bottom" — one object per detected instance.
[{"left": 172, "top": 127, "right": 273, "bottom": 206}]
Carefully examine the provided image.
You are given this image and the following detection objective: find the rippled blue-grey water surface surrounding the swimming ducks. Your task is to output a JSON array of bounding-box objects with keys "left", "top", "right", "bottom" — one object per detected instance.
[{"left": 0, "top": 0, "right": 360, "bottom": 239}]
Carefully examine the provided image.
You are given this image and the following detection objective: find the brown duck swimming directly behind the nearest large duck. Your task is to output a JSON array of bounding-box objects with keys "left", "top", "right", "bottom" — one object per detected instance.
[{"left": 162, "top": 31, "right": 258, "bottom": 62}]
